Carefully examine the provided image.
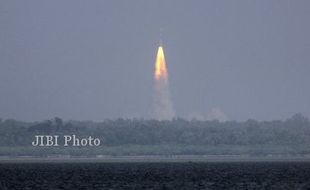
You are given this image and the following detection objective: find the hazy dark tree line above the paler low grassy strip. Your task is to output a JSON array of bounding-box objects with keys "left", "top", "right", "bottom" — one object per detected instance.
[{"left": 0, "top": 114, "right": 310, "bottom": 147}]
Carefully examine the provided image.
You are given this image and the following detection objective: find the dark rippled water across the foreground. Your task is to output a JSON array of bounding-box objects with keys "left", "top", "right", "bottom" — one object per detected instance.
[{"left": 0, "top": 162, "right": 310, "bottom": 190}]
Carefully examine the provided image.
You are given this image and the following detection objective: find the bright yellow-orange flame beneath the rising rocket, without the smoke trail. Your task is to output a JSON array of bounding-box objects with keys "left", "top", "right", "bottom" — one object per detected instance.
[{"left": 154, "top": 46, "right": 168, "bottom": 80}]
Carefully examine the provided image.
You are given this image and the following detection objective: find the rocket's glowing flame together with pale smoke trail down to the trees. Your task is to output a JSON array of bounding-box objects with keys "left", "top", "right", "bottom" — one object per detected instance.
[{"left": 154, "top": 46, "right": 175, "bottom": 120}]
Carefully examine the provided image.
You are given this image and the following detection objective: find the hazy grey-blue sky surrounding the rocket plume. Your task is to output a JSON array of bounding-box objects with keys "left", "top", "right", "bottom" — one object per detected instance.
[{"left": 0, "top": 0, "right": 310, "bottom": 121}]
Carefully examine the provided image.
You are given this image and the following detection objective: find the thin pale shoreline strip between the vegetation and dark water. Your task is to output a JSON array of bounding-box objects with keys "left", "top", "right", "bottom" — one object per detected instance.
[{"left": 0, "top": 155, "right": 310, "bottom": 164}]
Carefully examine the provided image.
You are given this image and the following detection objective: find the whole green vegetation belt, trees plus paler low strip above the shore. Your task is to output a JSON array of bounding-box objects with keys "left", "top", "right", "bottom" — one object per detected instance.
[{"left": 0, "top": 114, "right": 310, "bottom": 156}]
